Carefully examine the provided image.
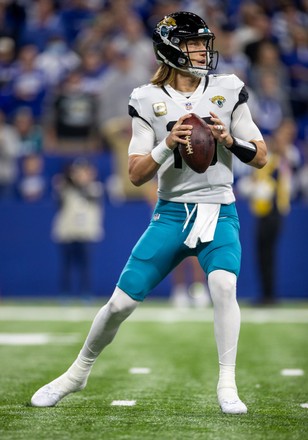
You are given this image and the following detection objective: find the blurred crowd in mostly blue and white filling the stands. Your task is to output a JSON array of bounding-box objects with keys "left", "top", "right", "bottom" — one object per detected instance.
[{"left": 0, "top": 0, "right": 308, "bottom": 202}]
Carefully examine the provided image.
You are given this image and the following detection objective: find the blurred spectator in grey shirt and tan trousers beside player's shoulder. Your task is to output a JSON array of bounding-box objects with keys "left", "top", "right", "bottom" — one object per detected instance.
[{"left": 98, "top": 42, "right": 149, "bottom": 202}]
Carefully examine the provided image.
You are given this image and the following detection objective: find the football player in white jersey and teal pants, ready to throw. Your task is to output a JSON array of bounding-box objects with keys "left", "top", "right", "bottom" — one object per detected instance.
[{"left": 31, "top": 12, "right": 267, "bottom": 414}]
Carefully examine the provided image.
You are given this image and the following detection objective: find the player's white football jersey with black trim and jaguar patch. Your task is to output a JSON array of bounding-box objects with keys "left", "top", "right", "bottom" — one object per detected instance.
[{"left": 129, "top": 75, "right": 262, "bottom": 204}]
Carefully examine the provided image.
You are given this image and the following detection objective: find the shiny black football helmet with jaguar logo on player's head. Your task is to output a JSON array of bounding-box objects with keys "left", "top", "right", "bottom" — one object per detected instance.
[{"left": 153, "top": 12, "right": 218, "bottom": 77}]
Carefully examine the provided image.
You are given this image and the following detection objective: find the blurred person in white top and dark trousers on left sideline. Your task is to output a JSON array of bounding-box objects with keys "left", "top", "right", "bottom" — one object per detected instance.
[{"left": 52, "top": 159, "right": 103, "bottom": 299}]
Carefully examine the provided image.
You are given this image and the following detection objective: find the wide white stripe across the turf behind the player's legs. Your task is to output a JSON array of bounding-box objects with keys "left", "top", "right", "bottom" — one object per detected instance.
[{"left": 0, "top": 305, "right": 308, "bottom": 324}]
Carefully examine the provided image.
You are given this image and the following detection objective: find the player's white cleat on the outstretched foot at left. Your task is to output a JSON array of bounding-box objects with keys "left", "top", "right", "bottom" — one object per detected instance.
[{"left": 31, "top": 373, "right": 87, "bottom": 408}]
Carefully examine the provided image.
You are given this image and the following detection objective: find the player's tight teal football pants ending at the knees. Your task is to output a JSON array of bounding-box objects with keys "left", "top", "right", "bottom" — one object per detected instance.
[{"left": 117, "top": 200, "right": 241, "bottom": 301}]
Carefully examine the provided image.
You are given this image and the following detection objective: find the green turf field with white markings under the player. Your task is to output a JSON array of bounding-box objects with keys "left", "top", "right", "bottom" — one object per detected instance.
[{"left": 0, "top": 305, "right": 308, "bottom": 440}]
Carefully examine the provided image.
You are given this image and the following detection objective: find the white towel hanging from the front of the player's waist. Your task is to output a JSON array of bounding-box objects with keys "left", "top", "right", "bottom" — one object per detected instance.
[{"left": 183, "top": 203, "right": 220, "bottom": 248}]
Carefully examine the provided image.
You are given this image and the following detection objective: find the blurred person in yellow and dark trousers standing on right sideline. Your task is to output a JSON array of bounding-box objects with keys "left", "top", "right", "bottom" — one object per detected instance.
[{"left": 237, "top": 120, "right": 299, "bottom": 306}]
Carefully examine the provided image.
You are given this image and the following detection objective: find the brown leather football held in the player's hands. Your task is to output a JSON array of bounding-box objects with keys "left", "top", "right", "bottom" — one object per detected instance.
[{"left": 178, "top": 113, "right": 215, "bottom": 174}]
